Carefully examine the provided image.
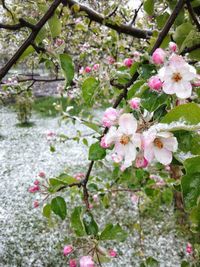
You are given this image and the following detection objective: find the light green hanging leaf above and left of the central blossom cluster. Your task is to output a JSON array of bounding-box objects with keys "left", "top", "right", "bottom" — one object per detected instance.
[{"left": 82, "top": 77, "right": 99, "bottom": 106}]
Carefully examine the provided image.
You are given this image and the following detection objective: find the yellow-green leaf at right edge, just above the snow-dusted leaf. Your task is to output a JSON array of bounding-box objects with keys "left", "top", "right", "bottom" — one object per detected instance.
[{"left": 161, "top": 103, "right": 200, "bottom": 125}]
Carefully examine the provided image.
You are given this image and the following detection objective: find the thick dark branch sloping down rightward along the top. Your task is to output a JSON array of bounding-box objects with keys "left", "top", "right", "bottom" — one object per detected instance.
[{"left": 62, "top": 0, "right": 152, "bottom": 39}]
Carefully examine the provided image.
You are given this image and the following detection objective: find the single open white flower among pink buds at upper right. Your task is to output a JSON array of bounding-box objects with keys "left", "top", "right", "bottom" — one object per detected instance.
[{"left": 158, "top": 54, "right": 196, "bottom": 99}]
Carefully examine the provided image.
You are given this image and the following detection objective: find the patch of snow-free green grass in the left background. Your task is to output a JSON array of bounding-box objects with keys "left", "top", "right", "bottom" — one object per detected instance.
[{"left": 32, "top": 96, "right": 68, "bottom": 117}]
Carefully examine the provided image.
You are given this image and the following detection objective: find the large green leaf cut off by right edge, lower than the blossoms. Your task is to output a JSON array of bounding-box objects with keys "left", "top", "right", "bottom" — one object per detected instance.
[{"left": 181, "top": 156, "right": 200, "bottom": 209}]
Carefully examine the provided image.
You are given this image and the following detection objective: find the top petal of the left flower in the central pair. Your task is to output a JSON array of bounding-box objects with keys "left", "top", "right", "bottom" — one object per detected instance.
[{"left": 119, "top": 113, "right": 137, "bottom": 135}]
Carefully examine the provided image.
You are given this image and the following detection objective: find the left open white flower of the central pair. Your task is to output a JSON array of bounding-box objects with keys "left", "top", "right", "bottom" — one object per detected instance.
[{"left": 105, "top": 113, "right": 141, "bottom": 170}]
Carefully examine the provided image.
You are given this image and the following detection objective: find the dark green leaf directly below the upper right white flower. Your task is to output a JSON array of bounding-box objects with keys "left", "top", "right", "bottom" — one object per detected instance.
[{"left": 141, "top": 89, "right": 168, "bottom": 112}]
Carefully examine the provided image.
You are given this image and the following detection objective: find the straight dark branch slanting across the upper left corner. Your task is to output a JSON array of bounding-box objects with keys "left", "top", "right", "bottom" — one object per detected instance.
[{"left": 0, "top": 0, "right": 62, "bottom": 80}]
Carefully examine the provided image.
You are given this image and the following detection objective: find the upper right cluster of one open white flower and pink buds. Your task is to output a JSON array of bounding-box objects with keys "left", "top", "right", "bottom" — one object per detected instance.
[{"left": 148, "top": 42, "right": 196, "bottom": 99}]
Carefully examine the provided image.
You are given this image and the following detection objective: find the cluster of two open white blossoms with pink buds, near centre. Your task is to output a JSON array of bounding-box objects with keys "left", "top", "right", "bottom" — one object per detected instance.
[{"left": 101, "top": 108, "right": 178, "bottom": 171}]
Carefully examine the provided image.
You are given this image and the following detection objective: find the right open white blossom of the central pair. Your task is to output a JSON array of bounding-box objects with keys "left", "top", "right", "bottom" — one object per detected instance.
[{"left": 143, "top": 129, "right": 178, "bottom": 165}]
